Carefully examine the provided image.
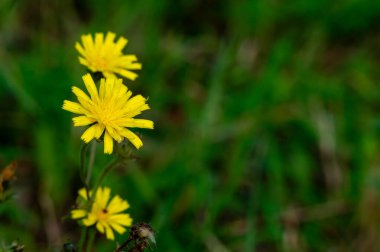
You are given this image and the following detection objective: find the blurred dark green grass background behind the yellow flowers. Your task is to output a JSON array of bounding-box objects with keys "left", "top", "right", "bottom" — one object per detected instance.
[{"left": 0, "top": 0, "right": 380, "bottom": 252}]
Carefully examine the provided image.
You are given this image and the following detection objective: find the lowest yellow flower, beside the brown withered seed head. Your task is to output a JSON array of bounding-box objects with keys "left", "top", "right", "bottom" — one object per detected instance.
[{"left": 71, "top": 187, "right": 132, "bottom": 240}]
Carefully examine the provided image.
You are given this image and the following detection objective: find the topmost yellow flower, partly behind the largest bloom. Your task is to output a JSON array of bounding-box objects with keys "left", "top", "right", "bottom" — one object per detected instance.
[{"left": 75, "top": 32, "right": 141, "bottom": 80}]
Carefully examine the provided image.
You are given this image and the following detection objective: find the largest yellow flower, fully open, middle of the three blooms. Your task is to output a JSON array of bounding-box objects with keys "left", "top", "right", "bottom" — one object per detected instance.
[{"left": 62, "top": 74, "right": 153, "bottom": 154}]
